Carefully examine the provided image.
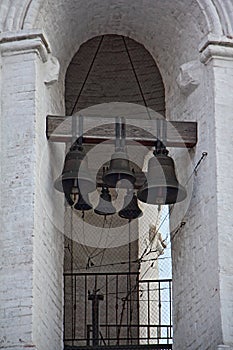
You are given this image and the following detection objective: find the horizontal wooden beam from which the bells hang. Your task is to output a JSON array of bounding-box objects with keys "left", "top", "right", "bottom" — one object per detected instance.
[{"left": 46, "top": 115, "right": 197, "bottom": 148}]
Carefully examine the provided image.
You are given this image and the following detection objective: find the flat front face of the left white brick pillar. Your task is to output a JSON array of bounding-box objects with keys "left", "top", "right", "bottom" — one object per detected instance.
[{"left": 0, "top": 50, "right": 35, "bottom": 348}]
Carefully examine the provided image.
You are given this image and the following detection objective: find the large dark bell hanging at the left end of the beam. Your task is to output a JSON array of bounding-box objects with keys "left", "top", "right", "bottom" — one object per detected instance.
[{"left": 54, "top": 145, "right": 96, "bottom": 205}]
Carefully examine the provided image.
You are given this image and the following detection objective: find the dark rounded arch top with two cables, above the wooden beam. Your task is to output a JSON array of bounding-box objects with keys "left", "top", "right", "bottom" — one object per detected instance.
[{"left": 65, "top": 34, "right": 165, "bottom": 115}]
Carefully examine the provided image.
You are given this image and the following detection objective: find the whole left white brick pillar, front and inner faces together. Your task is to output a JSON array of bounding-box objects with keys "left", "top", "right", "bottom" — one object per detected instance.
[{"left": 0, "top": 33, "right": 63, "bottom": 350}]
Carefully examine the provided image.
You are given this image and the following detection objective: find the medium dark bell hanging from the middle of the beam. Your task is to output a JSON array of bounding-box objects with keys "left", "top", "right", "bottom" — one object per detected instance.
[{"left": 103, "top": 151, "right": 136, "bottom": 187}]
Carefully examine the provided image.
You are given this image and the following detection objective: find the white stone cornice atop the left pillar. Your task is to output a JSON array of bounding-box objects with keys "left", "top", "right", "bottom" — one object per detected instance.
[{"left": 0, "top": 30, "right": 51, "bottom": 62}]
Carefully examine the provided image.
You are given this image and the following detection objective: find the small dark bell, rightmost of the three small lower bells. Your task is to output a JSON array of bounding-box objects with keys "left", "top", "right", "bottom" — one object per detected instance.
[{"left": 119, "top": 192, "right": 143, "bottom": 220}]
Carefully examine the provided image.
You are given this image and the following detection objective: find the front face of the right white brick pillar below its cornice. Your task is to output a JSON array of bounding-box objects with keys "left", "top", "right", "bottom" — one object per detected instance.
[{"left": 212, "top": 56, "right": 233, "bottom": 346}]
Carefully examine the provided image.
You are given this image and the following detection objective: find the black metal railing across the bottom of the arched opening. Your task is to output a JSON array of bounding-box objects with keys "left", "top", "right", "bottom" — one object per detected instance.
[{"left": 64, "top": 272, "right": 172, "bottom": 347}]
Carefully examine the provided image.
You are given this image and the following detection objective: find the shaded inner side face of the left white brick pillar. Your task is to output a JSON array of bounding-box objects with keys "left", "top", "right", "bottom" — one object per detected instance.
[{"left": 33, "top": 52, "right": 64, "bottom": 350}]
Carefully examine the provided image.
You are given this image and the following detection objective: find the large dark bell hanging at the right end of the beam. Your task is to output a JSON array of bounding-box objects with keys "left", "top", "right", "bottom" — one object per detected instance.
[{"left": 137, "top": 149, "right": 187, "bottom": 204}]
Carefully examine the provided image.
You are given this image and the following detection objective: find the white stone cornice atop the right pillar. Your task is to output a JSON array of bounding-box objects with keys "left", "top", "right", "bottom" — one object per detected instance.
[{"left": 199, "top": 35, "right": 233, "bottom": 64}]
